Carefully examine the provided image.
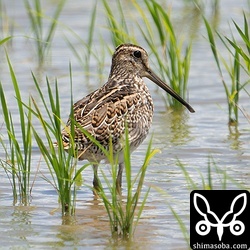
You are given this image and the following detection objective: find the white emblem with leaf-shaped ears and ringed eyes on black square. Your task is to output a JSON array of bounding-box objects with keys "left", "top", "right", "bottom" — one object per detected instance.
[{"left": 193, "top": 193, "right": 247, "bottom": 241}]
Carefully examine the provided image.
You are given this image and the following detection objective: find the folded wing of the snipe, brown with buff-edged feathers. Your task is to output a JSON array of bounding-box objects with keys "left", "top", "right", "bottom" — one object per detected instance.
[{"left": 62, "top": 81, "right": 134, "bottom": 142}]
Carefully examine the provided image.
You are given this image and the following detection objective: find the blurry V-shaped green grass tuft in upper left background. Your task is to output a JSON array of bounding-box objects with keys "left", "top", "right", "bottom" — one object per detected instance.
[{"left": 24, "top": 0, "right": 66, "bottom": 65}]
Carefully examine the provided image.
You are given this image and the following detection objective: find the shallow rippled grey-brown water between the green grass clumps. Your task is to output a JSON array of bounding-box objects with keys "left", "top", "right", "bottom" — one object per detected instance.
[{"left": 0, "top": 0, "right": 250, "bottom": 249}]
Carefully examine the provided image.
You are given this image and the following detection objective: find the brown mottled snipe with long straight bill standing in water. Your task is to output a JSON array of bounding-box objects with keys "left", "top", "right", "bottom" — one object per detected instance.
[{"left": 61, "top": 44, "right": 195, "bottom": 192}]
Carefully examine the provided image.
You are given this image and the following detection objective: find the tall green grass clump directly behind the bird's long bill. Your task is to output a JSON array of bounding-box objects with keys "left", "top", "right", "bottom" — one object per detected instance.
[{"left": 133, "top": 0, "right": 192, "bottom": 110}]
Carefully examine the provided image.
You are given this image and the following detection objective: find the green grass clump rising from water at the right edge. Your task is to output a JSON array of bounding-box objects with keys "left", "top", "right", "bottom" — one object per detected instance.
[{"left": 204, "top": 14, "right": 250, "bottom": 125}]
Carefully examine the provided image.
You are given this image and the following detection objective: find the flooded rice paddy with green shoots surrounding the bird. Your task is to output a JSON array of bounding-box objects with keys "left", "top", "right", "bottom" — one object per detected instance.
[{"left": 0, "top": 0, "right": 250, "bottom": 249}]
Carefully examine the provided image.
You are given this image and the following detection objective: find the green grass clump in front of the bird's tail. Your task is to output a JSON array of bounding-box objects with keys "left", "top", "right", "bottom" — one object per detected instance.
[{"left": 32, "top": 70, "right": 90, "bottom": 215}]
